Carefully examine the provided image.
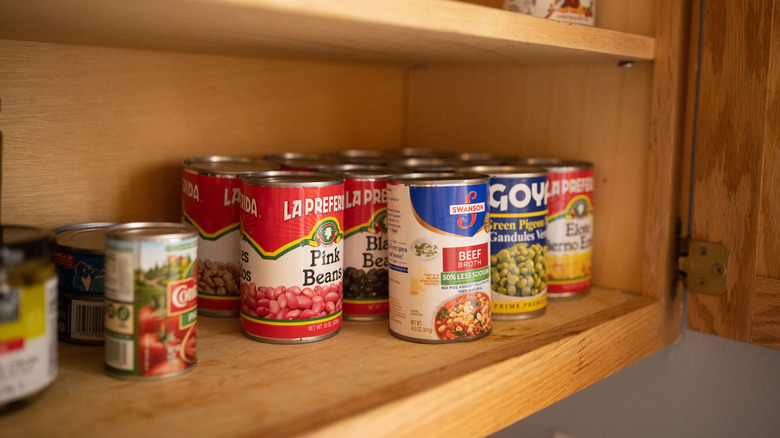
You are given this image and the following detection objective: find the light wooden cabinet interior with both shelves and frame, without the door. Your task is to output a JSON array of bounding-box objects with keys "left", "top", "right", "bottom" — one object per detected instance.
[{"left": 0, "top": 0, "right": 690, "bottom": 436}]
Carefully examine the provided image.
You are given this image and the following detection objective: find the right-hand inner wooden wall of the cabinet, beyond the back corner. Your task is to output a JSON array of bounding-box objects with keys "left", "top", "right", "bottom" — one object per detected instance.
[{"left": 407, "top": 63, "right": 652, "bottom": 291}]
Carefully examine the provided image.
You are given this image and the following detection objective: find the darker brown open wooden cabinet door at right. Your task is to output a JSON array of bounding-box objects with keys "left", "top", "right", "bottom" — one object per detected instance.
[{"left": 687, "top": 0, "right": 780, "bottom": 349}]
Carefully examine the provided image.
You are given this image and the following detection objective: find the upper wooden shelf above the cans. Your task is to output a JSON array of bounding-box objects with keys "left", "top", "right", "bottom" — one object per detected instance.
[{"left": 0, "top": 0, "right": 655, "bottom": 64}]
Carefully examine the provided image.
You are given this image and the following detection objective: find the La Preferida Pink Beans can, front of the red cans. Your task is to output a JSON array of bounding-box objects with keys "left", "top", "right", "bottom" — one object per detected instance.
[{"left": 240, "top": 171, "right": 345, "bottom": 343}]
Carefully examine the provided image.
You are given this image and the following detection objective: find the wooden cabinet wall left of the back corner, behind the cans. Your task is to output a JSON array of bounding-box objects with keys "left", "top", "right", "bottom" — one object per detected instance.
[{"left": 0, "top": 41, "right": 404, "bottom": 227}]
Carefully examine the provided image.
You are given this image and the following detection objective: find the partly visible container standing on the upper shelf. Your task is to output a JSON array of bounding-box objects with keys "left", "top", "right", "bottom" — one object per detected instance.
[{"left": 504, "top": 0, "right": 596, "bottom": 26}]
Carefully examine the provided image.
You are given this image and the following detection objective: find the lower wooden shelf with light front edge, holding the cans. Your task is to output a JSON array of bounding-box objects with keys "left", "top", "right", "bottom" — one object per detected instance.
[{"left": 0, "top": 288, "right": 664, "bottom": 437}]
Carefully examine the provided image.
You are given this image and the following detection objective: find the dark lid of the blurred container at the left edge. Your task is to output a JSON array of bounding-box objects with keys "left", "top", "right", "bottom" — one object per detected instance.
[{"left": 0, "top": 225, "right": 52, "bottom": 268}]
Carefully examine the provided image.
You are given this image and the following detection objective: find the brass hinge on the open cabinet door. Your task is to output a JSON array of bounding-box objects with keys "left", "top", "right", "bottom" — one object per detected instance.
[{"left": 677, "top": 238, "right": 729, "bottom": 295}]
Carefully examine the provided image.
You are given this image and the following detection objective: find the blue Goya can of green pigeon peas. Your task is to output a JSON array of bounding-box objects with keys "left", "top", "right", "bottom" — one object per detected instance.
[{"left": 468, "top": 165, "right": 547, "bottom": 320}]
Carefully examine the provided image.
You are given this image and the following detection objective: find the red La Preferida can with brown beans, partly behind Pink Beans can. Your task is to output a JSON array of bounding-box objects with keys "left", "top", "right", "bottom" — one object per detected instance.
[{"left": 182, "top": 156, "right": 279, "bottom": 316}]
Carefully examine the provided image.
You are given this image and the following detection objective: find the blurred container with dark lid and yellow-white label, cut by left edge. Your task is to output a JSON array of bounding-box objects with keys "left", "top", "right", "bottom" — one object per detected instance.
[{"left": 0, "top": 225, "right": 57, "bottom": 413}]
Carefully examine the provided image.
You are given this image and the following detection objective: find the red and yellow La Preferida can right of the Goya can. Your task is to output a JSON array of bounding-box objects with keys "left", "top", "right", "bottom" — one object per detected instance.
[{"left": 527, "top": 159, "right": 594, "bottom": 298}]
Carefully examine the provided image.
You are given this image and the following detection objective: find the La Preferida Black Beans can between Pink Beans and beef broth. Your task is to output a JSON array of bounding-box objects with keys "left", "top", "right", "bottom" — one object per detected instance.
[{"left": 339, "top": 169, "right": 392, "bottom": 320}]
